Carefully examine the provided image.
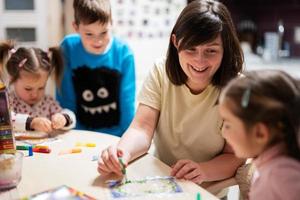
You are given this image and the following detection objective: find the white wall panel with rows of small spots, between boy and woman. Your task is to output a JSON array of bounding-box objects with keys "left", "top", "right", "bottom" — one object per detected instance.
[{"left": 112, "top": 0, "right": 187, "bottom": 38}]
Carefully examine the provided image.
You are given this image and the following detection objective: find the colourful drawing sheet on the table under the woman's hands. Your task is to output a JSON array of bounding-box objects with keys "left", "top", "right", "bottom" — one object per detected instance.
[{"left": 108, "top": 176, "right": 182, "bottom": 198}]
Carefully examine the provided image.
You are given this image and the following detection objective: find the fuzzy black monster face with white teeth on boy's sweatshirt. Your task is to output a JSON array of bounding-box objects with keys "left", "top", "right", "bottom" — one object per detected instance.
[{"left": 73, "top": 66, "right": 120, "bottom": 128}]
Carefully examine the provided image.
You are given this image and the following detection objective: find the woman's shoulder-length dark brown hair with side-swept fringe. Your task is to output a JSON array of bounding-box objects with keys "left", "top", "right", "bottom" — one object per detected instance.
[{"left": 166, "top": 0, "right": 243, "bottom": 87}]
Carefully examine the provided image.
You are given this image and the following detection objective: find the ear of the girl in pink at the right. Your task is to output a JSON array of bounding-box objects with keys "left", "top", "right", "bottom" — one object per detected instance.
[{"left": 253, "top": 122, "right": 271, "bottom": 147}]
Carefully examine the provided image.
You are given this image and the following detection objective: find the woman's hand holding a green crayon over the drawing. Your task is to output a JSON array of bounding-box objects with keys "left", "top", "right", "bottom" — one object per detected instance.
[{"left": 98, "top": 146, "right": 129, "bottom": 175}]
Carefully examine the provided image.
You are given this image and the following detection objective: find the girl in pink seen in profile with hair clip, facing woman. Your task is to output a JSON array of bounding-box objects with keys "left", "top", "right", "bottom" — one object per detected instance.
[{"left": 219, "top": 70, "right": 300, "bottom": 200}]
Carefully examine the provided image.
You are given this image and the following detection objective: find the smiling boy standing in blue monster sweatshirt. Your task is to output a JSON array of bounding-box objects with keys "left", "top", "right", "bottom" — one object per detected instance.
[{"left": 56, "top": 0, "right": 135, "bottom": 136}]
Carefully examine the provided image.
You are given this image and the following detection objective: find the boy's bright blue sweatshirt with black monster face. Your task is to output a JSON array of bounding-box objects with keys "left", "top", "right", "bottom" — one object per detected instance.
[{"left": 56, "top": 34, "right": 135, "bottom": 136}]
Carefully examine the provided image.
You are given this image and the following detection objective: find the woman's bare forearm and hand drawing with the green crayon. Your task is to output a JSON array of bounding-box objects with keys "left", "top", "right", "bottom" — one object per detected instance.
[{"left": 98, "top": 104, "right": 159, "bottom": 174}]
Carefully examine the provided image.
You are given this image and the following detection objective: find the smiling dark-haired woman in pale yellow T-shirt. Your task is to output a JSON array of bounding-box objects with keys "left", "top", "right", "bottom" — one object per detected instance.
[{"left": 98, "top": 0, "right": 243, "bottom": 195}]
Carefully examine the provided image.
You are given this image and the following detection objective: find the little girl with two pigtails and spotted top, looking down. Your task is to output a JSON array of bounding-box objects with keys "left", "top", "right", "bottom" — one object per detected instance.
[{"left": 0, "top": 41, "right": 76, "bottom": 133}]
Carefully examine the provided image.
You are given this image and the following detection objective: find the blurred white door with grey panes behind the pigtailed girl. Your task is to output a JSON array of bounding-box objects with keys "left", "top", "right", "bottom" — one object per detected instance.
[{"left": 0, "top": 0, "right": 64, "bottom": 48}]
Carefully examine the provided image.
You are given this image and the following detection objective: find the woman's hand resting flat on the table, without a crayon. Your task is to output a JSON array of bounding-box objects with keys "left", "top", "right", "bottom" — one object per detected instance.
[{"left": 171, "top": 160, "right": 206, "bottom": 184}]
